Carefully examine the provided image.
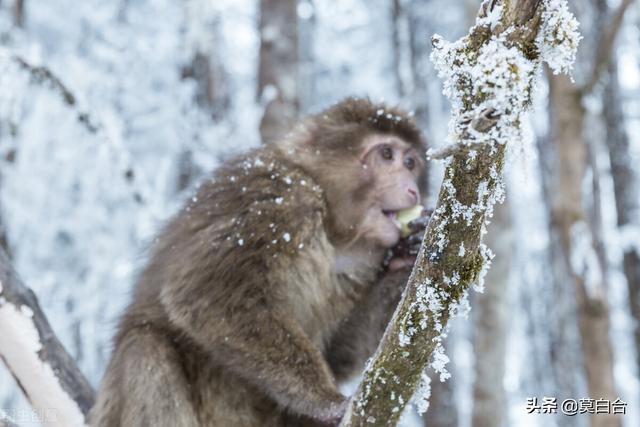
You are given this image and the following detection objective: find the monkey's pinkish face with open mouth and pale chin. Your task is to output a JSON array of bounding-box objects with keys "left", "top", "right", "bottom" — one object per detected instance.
[{"left": 359, "top": 134, "right": 424, "bottom": 247}]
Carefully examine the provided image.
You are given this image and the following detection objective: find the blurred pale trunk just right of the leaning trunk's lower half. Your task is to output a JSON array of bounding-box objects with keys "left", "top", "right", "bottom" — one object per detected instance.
[{"left": 471, "top": 203, "right": 513, "bottom": 427}]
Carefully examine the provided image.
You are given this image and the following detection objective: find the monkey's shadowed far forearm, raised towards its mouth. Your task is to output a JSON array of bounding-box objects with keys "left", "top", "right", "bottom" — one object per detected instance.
[{"left": 326, "top": 268, "right": 411, "bottom": 381}]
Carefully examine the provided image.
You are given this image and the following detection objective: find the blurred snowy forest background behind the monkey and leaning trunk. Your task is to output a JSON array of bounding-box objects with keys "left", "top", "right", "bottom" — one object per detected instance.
[{"left": 0, "top": 0, "right": 640, "bottom": 427}]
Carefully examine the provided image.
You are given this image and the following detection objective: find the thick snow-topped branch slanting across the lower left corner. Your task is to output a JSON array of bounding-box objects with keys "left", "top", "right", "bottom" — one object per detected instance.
[{"left": 0, "top": 248, "right": 94, "bottom": 426}]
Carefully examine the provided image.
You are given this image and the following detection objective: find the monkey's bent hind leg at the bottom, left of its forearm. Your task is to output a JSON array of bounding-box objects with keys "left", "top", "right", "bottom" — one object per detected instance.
[{"left": 91, "top": 329, "right": 198, "bottom": 427}]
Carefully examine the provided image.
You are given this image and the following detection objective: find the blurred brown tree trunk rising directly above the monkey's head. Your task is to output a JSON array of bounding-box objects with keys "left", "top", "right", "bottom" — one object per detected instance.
[{"left": 258, "top": 0, "right": 299, "bottom": 143}]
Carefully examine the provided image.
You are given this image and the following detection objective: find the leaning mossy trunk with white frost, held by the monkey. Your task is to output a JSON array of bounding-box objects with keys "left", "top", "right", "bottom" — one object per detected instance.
[{"left": 342, "top": 0, "right": 580, "bottom": 426}]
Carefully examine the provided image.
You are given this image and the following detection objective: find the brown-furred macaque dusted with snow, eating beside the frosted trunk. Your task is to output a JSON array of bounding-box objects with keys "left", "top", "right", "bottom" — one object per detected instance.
[{"left": 90, "top": 98, "right": 428, "bottom": 427}]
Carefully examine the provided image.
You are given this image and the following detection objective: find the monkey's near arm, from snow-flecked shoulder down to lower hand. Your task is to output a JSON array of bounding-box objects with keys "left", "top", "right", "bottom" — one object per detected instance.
[{"left": 158, "top": 169, "right": 345, "bottom": 422}]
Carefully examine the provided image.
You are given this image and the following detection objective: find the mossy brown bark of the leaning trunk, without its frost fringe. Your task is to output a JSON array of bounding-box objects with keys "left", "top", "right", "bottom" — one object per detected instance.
[{"left": 341, "top": 0, "right": 564, "bottom": 426}]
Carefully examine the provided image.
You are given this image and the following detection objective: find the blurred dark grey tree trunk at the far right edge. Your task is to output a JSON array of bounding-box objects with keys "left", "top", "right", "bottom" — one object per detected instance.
[{"left": 604, "top": 61, "right": 640, "bottom": 378}]
